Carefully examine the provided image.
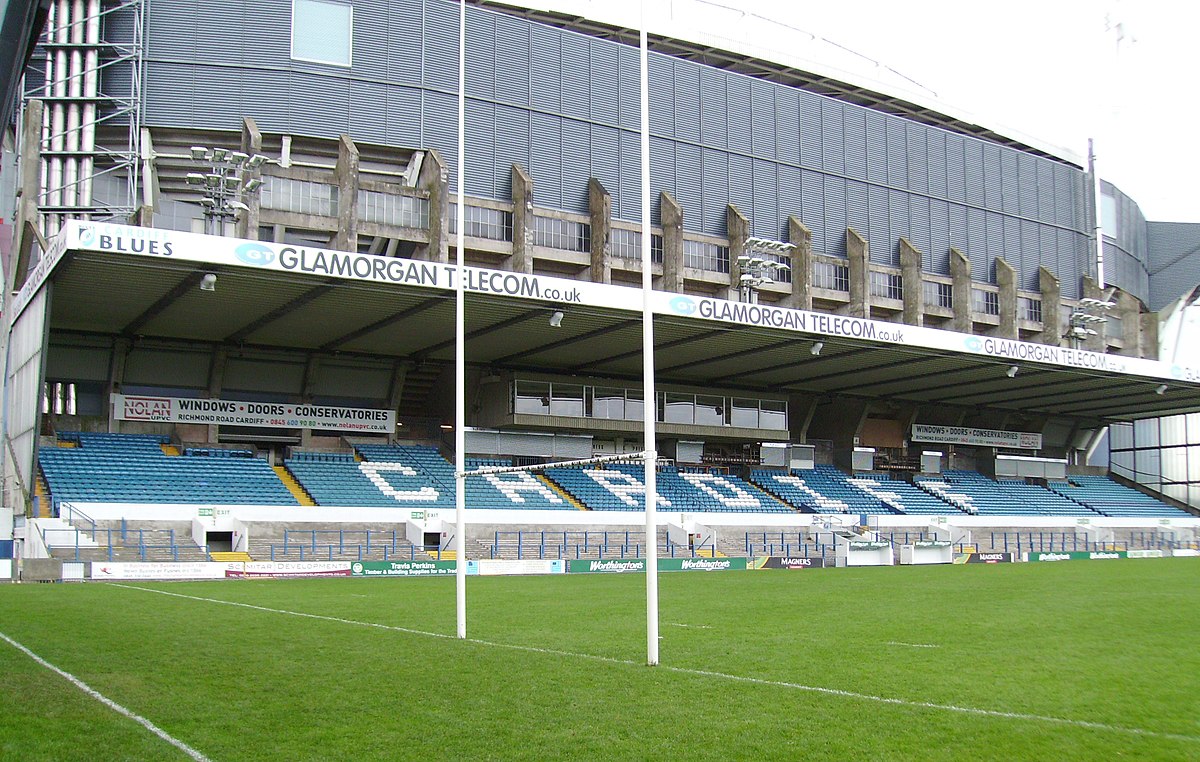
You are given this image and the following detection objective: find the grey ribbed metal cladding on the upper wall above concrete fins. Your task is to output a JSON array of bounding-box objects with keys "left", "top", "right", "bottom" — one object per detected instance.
[{"left": 110, "top": 0, "right": 1099, "bottom": 299}]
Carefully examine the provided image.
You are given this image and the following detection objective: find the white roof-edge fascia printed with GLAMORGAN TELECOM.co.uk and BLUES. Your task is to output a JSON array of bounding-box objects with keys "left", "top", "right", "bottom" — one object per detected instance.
[{"left": 32, "top": 220, "right": 1200, "bottom": 382}]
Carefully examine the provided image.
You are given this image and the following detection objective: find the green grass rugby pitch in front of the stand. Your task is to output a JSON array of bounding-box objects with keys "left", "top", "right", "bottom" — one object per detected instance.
[{"left": 0, "top": 558, "right": 1200, "bottom": 761}]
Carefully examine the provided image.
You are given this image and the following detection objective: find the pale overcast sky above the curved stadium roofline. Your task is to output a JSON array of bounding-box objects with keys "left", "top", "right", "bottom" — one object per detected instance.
[{"left": 568, "top": 0, "right": 1200, "bottom": 222}]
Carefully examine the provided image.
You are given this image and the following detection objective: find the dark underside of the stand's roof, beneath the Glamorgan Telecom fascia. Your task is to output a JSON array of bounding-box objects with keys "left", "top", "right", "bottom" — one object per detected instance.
[{"left": 37, "top": 236, "right": 1200, "bottom": 424}]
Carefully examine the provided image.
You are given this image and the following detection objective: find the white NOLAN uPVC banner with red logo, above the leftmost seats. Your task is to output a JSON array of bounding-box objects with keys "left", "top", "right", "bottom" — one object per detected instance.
[{"left": 112, "top": 394, "right": 396, "bottom": 434}]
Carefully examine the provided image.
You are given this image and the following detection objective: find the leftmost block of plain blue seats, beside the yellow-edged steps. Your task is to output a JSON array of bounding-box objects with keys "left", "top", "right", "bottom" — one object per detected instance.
[{"left": 38, "top": 432, "right": 296, "bottom": 505}]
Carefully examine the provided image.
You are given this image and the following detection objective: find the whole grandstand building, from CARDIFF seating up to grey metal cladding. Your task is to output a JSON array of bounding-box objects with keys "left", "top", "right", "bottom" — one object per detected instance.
[{"left": 0, "top": 0, "right": 1200, "bottom": 570}]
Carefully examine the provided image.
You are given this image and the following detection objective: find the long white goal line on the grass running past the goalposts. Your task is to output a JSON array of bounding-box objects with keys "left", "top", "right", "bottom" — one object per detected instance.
[{"left": 108, "top": 590, "right": 1200, "bottom": 743}]
